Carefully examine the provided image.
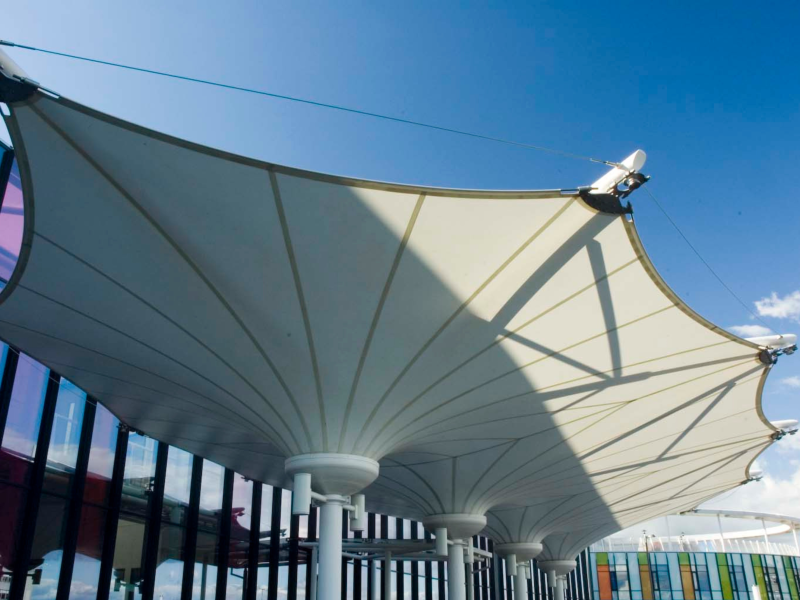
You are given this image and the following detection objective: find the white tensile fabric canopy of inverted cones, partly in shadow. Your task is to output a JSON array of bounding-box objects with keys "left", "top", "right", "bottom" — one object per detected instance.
[{"left": 0, "top": 86, "right": 775, "bottom": 558}]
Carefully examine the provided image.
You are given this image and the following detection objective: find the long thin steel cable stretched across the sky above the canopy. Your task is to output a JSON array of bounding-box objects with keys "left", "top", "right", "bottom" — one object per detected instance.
[{"left": 0, "top": 40, "right": 620, "bottom": 167}]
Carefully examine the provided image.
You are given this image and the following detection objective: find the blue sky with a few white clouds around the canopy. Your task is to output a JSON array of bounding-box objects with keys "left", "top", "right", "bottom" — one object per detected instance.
[{"left": 0, "top": 1, "right": 800, "bottom": 516}]
